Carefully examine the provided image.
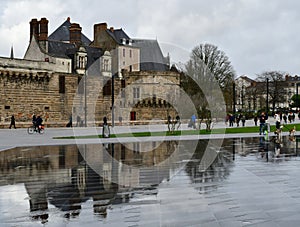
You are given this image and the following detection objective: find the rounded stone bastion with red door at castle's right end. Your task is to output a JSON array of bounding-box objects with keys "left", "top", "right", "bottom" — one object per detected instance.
[{"left": 116, "top": 71, "right": 180, "bottom": 122}]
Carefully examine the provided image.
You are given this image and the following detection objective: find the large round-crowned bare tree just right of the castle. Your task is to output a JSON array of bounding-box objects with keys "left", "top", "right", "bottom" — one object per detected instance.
[{"left": 183, "top": 44, "right": 235, "bottom": 127}]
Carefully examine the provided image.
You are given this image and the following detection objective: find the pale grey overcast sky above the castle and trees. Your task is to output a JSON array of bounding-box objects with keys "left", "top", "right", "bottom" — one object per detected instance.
[{"left": 0, "top": 0, "right": 300, "bottom": 78}]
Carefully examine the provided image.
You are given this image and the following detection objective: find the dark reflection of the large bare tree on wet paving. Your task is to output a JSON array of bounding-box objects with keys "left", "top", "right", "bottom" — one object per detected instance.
[{"left": 186, "top": 140, "right": 232, "bottom": 193}]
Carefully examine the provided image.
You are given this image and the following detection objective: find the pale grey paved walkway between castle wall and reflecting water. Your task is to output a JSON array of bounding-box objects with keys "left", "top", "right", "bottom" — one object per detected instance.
[{"left": 0, "top": 118, "right": 300, "bottom": 150}]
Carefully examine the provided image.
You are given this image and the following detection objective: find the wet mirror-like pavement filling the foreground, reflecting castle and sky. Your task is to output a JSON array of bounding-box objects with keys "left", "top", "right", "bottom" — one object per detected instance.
[{"left": 0, "top": 137, "right": 300, "bottom": 227}]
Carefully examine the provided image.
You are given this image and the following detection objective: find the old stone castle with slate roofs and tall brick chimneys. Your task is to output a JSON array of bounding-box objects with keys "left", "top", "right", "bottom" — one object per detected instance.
[{"left": 0, "top": 18, "right": 180, "bottom": 127}]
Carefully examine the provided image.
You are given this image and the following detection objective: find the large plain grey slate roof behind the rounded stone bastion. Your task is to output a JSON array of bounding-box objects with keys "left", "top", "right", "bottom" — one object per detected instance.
[{"left": 132, "top": 39, "right": 169, "bottom": 71}]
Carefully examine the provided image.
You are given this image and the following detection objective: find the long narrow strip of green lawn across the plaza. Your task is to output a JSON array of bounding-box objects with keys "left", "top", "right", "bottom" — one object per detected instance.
[{"left": 53, "top": 124, "right": 300, "bottom": 139}]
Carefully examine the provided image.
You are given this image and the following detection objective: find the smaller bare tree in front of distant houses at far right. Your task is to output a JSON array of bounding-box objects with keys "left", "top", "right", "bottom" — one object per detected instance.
[{"left": 256, "top": 71, "right": 287, "bottom": 112}]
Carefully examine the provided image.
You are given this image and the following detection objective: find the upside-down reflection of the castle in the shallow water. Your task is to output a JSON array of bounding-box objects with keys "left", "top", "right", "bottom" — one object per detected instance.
[{"left": 0, "top": 141, "right": 183, "bottom": 222}]
